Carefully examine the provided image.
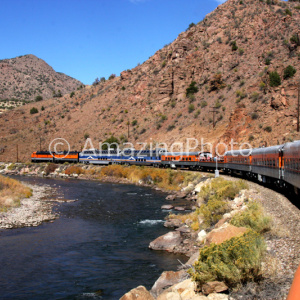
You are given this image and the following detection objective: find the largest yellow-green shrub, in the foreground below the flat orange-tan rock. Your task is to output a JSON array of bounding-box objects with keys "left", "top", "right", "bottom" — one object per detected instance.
[{"left": 189, "top": 230, "right": 265, "bottom": 287}]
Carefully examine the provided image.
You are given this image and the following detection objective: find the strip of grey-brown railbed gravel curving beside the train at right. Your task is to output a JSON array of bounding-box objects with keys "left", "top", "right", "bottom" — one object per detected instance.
[{"left": 226, "top": 176, "right": 300, "bottom": 300}]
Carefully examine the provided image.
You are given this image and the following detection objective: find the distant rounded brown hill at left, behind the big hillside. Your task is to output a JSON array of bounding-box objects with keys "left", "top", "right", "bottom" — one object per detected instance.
[{"left": 0, "top": 54, "right": 82, "bottom": 105}]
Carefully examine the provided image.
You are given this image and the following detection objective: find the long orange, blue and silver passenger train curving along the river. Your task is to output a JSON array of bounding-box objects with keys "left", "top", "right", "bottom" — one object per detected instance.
[{"left": 31, "top": 140, "right": 300, "bottom": 194}]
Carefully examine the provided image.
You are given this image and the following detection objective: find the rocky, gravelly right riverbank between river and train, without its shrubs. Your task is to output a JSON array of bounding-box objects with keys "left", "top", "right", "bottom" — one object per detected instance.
[{"left": 121, "top": 177, "right": 300, "bottom": 300}]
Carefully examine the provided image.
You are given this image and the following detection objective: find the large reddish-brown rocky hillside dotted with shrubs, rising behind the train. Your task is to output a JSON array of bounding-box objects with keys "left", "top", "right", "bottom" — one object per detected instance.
[{"left": 0, "top": 0, "right": 300, "bottom": 161}]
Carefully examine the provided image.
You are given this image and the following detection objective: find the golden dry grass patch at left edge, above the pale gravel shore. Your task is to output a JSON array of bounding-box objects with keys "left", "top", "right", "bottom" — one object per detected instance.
[{"left": 0, "top": 175, "right": 32, "bottom": 211}]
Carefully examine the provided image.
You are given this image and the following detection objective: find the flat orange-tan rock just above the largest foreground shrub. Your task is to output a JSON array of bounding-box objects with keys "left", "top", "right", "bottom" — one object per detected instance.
[{"left": 205, "top": 223, "right": 248, "bottom": 245}]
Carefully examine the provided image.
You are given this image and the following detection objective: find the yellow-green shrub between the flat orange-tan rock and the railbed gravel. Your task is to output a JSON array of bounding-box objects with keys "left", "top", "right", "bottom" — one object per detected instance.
[{"left": 230, "top": 202, "right": 271, "bottom": 233}]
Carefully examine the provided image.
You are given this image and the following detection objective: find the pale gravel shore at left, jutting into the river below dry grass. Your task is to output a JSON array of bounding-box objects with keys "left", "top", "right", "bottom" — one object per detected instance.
[{"left": 0, "top": 184, "right": 57, "bottom": 229}]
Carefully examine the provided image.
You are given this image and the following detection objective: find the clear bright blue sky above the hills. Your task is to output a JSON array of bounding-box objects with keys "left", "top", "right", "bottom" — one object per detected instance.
[{"left": 0, "top": 0, "right": 224, "bottom": 84}]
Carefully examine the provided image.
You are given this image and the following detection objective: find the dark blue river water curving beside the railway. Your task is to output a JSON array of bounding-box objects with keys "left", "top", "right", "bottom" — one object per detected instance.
[{"left": 0, "top": 177, "right": 186, "bottom": 300}]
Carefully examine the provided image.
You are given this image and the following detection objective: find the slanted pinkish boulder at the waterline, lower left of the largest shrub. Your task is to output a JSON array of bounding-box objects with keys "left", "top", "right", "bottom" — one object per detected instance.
[{"left": 150, "top": 270, "right": 187, "bottom": 297}]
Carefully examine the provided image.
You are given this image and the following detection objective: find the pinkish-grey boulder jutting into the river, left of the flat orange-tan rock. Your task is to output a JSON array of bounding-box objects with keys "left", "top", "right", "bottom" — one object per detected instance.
[{"left": 149, "top": 231, "right": 182, "bottom": 252}]
